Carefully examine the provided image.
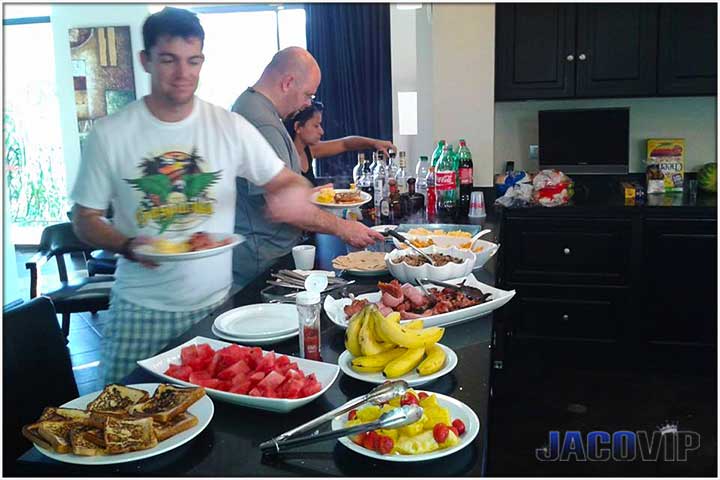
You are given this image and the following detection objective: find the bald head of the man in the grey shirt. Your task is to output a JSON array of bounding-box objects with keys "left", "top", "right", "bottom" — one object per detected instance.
[{"left": 255, "top": 47, "right": 320, "bottom": 118}]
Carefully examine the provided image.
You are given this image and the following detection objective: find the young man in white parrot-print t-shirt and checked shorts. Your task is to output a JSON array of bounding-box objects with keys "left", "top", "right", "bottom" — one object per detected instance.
[{"left": 72, "top": 8, "right": 376, "bottom": 383}]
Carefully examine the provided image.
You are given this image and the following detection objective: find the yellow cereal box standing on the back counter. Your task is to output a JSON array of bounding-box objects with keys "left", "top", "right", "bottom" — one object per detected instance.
[{"left": 646, "top": 138, "right": 685, "bottom": 193}]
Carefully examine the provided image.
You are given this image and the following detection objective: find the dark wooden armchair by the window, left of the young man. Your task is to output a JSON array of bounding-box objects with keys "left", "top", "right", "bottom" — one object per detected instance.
[{"left": 25, "top": 222, "right": 115, "bottom": 337}]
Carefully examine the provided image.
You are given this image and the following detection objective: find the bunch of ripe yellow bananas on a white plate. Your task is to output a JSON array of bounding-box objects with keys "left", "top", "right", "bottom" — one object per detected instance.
[{"left": 345, "top": 305, "right": 445, "bottom": 378}]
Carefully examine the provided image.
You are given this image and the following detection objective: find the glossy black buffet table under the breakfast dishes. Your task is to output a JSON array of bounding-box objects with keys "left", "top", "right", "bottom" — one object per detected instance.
[{"left": 16, "top": 225, "right": 495, "bottom": 477}]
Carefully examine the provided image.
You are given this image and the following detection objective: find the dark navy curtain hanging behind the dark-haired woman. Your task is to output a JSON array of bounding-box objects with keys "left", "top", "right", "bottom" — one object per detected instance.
[{"left": 305, "top": 3, "right": 392, "bottom": 176}]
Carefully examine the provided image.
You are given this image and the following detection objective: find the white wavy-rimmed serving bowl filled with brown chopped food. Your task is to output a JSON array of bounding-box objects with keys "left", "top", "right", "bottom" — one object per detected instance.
[{"left": 385, "top": 245, "right": 476, "bottom": 283}]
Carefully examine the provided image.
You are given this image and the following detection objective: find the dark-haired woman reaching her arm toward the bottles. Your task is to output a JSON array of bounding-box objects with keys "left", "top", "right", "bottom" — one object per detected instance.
[{"left": 285, "top": 100, "right": 397, "bottom": 184}]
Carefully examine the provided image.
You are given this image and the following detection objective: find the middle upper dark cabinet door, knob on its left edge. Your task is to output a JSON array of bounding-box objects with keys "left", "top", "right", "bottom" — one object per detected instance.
[{"left": 575, "top": 3, "right": 657, "bottom": 97}]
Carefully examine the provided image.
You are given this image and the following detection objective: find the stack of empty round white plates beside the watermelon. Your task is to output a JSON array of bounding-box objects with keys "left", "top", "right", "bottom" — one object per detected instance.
[{"left": 212, "top": 303, "right": 298, "bottom": 345}]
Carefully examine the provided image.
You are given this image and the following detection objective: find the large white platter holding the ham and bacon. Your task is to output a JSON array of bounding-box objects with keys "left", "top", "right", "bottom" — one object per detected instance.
[{"left": 323, "top": 274, "right": 515, "bottom": 328}]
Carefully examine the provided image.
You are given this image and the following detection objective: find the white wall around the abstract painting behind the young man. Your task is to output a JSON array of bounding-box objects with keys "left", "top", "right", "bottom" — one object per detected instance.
[{"left": 50, "top": 3, "right": 150, "bottom": 193}]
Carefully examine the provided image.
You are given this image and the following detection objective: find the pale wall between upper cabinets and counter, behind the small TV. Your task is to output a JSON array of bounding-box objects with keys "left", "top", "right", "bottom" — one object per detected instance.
[{"left": 495, "top": 97, "right": 717, "bottom": 173}]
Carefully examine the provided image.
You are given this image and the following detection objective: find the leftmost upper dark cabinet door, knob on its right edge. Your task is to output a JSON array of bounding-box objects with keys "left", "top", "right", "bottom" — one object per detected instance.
[{"left": 495, "top": 3, "right": 575, "bottom": 99}]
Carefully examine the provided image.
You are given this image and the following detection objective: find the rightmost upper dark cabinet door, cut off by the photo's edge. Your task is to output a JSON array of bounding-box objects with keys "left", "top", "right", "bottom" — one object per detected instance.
[{"left": 658, "top": 3, "right": 718, "bottom": 95}]
